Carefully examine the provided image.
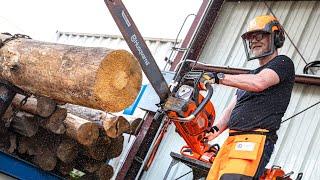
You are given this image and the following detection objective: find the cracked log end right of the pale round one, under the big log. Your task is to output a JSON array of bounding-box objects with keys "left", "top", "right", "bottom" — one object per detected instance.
[{"left": 103, "top": 116, "right": 130, "bottom": 138}]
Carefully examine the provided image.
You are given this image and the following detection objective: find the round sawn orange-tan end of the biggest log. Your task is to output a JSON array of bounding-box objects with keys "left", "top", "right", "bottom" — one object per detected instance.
[{"left": 94, "top": 50, "right": 142, "bottom": 112}]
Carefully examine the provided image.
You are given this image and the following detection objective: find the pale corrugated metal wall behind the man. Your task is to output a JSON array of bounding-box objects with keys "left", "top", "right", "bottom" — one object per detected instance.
[{"left": 143, "top": 1, "right": 320, "bottom": 180}]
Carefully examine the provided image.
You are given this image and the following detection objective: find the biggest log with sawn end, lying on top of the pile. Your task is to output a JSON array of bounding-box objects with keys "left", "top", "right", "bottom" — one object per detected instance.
[{"left": 0, "top": 34, "right": 142, "bottom": 112}]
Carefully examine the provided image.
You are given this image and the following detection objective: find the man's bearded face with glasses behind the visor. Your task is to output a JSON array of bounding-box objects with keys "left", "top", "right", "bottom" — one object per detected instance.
[{"left": 248, "top": 32, "right": 271, "bottom": 57}]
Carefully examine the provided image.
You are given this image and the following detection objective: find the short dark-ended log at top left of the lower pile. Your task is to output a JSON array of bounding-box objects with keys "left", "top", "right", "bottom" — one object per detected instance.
[{"left": 12, "top": 94, "right": 56, "bottom": 117}]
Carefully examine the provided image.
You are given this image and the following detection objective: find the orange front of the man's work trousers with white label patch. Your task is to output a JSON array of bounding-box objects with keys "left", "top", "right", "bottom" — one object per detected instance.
[{"left": 207, "top": 130, "right": 268, "bottom": 180}]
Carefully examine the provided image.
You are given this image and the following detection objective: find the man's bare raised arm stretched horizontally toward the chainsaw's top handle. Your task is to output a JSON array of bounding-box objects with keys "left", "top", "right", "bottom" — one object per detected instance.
[{"left": 219, "top": 68, "right": 280, "bottom": 92}]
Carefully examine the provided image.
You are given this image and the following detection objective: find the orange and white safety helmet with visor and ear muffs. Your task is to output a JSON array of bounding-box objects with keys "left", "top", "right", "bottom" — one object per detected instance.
[{"left": 241, "top": 15, "right": 285, "bottom": 60}]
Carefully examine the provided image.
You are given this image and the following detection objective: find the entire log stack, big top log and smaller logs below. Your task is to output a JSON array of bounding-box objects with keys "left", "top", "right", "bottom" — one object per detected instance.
[{"left": 0, "top": 34, "right": 142, "bottom": 179}]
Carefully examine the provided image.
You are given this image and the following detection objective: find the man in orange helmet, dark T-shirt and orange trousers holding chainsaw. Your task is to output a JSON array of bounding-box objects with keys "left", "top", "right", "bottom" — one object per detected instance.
[{"left": 207, "top": 16, "right": 295, "bottom": 180}]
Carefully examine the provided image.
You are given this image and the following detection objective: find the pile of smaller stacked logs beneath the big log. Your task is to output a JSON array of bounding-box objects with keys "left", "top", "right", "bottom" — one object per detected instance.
[{"left": 0, "top": 94, "right": 142, "bottom": 179}]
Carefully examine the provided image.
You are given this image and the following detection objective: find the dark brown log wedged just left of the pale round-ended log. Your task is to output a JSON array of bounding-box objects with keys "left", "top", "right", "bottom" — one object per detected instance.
[{"left": 39, "top": 108, "right": 67, "bottom": 134}]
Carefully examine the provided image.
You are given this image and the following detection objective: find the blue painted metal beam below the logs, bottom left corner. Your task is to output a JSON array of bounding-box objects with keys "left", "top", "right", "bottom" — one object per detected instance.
[{"left": 0, "top": 151, "right": 63, "bottom": 180}]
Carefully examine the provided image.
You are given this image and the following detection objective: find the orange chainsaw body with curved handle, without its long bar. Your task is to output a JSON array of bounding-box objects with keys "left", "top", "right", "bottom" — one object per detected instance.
[{"left": 163, "top": 71, "right": 219, "bottom": 162}]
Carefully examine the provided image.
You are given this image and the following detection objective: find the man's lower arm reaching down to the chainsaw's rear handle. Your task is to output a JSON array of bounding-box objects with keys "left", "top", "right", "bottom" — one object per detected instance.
[{"left": 206, "top": 95, "right": 237, "bottom": 141}]
